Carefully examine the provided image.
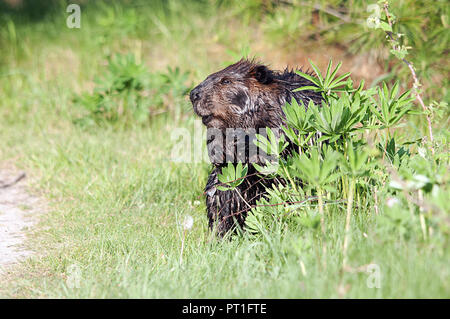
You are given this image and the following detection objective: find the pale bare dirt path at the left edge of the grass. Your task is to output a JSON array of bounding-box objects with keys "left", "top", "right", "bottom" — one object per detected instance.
[{"left": 0, "top": 168, "right": 41, "bottom": 274}]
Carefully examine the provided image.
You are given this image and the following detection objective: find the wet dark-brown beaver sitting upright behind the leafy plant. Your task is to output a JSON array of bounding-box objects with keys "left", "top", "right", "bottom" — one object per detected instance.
[{"left": 190, "top": 59, "right": 322, "bottom": 237}]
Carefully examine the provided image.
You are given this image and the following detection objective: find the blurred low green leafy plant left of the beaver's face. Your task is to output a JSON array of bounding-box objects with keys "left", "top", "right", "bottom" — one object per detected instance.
[{"left": 73, "top": 54, "right": 190, "bottom": 126}]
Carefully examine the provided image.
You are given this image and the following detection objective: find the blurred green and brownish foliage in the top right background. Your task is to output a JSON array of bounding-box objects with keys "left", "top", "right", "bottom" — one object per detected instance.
[{"left": 248, "top": 0, "right": 450, "bottom": 100}]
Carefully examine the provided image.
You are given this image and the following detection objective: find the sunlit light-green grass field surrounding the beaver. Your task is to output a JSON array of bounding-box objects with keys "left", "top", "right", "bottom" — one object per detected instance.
[{"left": 0, "top": 1, "right": 450, "bottom": 298}]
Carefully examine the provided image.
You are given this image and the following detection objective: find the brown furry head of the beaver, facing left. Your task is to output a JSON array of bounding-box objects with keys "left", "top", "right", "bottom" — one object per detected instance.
[{"left": 190, "top": 60, "right": 320, "bottom": 129}]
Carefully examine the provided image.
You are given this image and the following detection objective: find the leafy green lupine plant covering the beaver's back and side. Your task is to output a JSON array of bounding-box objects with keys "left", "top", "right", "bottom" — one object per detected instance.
[{"left": 219, "top": 53, "right": 448, "bottom": 270}]
